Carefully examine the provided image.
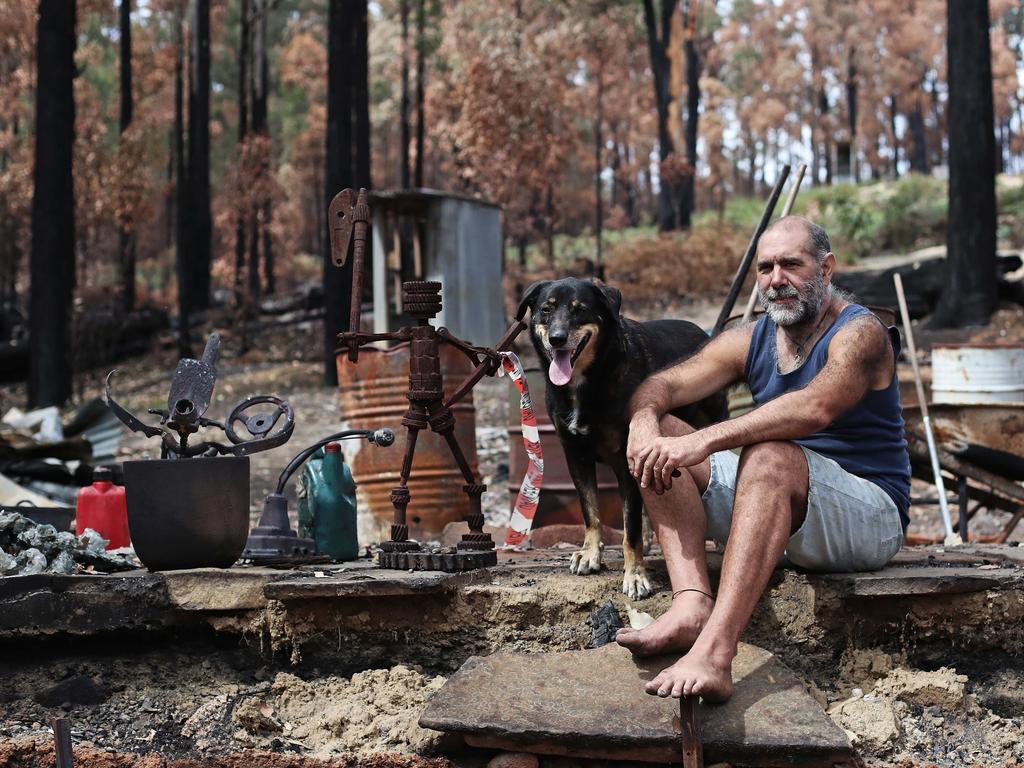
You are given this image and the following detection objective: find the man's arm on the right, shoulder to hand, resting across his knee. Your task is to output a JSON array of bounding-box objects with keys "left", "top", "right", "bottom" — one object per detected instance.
[{"left": 634, "top": 317, "right": 895, "bottom": 487}]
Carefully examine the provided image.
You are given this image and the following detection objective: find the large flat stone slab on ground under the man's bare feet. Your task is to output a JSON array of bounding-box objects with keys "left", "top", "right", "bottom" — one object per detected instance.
[{"left": 420, "top": 643, "right": 851, "bottom": 766}]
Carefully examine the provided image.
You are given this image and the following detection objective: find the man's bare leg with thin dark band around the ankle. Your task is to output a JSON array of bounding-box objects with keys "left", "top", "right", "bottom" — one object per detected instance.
[{"left": 615, "top": 416, "right": 713, "bottom": 655}]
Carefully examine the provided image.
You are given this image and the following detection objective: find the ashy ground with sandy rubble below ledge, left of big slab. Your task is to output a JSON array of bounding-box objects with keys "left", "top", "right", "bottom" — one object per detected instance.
[{"left": 0, "top": 644, "right": 445, "bottom": 765}]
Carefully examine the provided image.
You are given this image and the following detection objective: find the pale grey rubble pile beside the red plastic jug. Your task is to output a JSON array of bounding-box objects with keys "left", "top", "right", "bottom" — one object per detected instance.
[{"left": 0, "top": 512, "right": 138, "bottom": 575}]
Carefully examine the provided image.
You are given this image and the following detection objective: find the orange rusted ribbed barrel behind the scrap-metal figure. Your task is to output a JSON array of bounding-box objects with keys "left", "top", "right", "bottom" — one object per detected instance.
[{"left": 338, "top": 344, "right": 479, "bottom": 543}]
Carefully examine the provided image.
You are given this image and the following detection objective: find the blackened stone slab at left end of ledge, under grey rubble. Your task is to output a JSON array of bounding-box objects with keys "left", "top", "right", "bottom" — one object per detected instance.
[{"left": 0, "top": 571, "right": 171, "bottom": 638}]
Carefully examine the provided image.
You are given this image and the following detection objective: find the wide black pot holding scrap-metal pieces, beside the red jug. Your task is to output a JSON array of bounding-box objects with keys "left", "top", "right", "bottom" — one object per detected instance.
[{"left": 124, "top": 456, "right": 249, "bottom": 570}]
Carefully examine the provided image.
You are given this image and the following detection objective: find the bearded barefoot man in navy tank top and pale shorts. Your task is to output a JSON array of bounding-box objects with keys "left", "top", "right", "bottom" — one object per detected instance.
[{"left": 616, "top": 216, "right": 910, "bottom": 701}]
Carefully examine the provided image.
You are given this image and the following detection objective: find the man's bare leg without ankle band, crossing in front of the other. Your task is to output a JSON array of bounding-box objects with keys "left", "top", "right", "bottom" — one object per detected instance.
[{"left": 645, "top": 442, "right": 808, "bottom": 701}]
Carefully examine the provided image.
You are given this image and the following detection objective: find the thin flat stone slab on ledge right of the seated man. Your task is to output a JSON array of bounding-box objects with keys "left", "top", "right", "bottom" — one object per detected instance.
[{"left": 808, "top": 566, "right": 1024, "bottom": 597}]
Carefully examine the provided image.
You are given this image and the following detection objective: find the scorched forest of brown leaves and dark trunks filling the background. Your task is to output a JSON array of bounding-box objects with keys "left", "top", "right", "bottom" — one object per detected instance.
[{"left": 0, "top": 0, "right": 1024, "bottom": 404}]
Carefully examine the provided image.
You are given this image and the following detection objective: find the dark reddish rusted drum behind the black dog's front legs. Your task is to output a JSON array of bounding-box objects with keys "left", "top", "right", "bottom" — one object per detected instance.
[{"left": 508, "top": 368, "right": 623, "bottom": 528}]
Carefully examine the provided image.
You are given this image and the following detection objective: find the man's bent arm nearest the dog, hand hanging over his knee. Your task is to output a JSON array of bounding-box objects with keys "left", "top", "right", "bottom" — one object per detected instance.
[{"left": 626, "top": 325, "right": 754, "bottom": 481}]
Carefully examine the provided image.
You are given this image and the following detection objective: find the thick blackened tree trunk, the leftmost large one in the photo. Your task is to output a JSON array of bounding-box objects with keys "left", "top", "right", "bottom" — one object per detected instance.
[{"left": 28, "top": 0, "right": 76, "bottom": 408}]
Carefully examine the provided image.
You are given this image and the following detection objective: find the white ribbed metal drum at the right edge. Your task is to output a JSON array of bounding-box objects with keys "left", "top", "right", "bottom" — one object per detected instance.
[{"left": 932, "top": 344, "right": 1024, "bottom": 406}]
